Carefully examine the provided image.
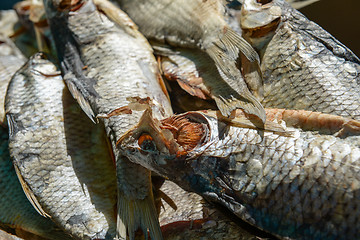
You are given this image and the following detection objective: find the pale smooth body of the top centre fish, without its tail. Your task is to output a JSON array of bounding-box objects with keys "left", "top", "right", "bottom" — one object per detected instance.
[{"left": 119, "top": 0, "right": 226, "bottom": 48}]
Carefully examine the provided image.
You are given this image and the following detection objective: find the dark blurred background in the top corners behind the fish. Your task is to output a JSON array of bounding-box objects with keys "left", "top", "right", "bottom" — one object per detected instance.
[{"left": 0, "top": 0, "right": 360, "bottom": 56}]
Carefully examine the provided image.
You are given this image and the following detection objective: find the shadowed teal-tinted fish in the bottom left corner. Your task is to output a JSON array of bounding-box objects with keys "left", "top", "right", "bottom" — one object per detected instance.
[{"left": 0, "top": 126, "right": 72, "bottom": 240}]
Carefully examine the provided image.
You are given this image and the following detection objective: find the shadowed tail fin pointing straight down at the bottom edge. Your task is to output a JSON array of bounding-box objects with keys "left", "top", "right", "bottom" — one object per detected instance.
[{"left": 117, "top": 178, "right": 163, "bottom": 240}]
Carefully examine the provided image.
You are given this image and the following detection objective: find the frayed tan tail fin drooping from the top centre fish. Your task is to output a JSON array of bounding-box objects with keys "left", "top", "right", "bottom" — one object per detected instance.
[{"left": 206, "top": 29, "right": 266, "bottom": 123}]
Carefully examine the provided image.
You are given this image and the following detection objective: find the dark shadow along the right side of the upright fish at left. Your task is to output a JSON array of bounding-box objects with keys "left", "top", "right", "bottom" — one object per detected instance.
[{"left": 63, "top": 86, "right": 117, "bottom": 237}]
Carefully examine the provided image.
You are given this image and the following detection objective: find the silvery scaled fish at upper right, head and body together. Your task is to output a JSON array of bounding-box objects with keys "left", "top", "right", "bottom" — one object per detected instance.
[{"left": 241, "top": 0, "right": 360, "bottom": 120}]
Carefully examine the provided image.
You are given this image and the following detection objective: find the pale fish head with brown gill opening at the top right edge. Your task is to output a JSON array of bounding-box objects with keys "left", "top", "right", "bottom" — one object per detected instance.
[{"left": 240, "top": 0, "right": 282, "bottom": 51}]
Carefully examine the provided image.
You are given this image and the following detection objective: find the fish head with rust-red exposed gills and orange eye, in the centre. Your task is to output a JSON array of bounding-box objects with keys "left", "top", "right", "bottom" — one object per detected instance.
[{"left": 117, "top": 109, "right": 210, "bottom": 176}]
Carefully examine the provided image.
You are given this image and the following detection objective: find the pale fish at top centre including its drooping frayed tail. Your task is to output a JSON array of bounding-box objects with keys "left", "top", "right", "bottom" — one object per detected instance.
[{"left": 118, "top": 0, "right": 265, "bottom": 122}]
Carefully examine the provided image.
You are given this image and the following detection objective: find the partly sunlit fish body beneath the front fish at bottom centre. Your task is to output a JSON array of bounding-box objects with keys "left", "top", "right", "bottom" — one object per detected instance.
[{"left": 155, "top": 180, "right": 264, "bottom": 240}]
